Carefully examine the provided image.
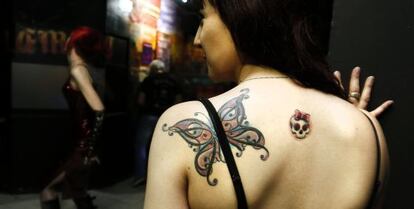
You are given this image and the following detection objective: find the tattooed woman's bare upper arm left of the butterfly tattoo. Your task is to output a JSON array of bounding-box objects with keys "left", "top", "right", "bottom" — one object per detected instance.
[{"left": 144, "top": 107, "right": 189, "bottom": 209}]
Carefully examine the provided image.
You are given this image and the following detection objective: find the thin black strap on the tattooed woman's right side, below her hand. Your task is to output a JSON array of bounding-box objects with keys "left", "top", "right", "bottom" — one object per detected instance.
[{"left": 362, "top": 112, "right": 381, "bottom": 209}]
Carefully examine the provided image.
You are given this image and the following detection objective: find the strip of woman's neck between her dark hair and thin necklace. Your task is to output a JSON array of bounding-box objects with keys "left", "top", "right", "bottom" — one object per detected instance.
[{"left": 238, "top": 65, "right": 286, "bottom": 83}]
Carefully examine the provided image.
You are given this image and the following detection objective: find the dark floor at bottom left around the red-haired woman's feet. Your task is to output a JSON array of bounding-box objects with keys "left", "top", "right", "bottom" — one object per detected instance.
[{"left": 0, "top": 179, "right": 145, "bottom": 209}]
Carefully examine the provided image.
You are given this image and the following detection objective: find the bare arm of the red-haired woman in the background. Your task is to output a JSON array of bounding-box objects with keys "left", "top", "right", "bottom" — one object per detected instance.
[{"left": 71, "top": 65, "right": 105, "bottom": 111}]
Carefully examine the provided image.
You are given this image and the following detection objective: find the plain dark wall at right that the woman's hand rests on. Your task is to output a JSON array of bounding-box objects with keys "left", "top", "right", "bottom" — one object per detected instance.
[{"left": 330, "top": 0, "right": 414, "bottom": 209}]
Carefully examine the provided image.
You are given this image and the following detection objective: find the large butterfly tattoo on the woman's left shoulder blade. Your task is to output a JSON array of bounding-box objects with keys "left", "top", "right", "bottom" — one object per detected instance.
[{"left": 162, "top": 89, "right": 269, "bottom": 186}]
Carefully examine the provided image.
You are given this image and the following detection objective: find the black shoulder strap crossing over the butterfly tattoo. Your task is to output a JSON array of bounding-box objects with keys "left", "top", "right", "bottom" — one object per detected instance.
[{"left": 200, "top": 99, "right": 247, "bottom": 209}]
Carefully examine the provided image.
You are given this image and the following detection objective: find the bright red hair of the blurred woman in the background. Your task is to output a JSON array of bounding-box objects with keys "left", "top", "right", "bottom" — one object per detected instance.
[{"left": 66, "top": 26, "right": 107, "bottom": 67}]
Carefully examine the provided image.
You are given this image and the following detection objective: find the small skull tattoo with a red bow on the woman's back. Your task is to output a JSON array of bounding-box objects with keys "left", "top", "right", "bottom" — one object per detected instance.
[{"left": 290, "top": 110, "right": 310, "bottom": 139}]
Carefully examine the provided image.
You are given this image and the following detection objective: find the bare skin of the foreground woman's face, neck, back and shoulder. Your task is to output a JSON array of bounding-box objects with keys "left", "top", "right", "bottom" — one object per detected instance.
[{"left": 144, "top": 1, "right": 388, "bottom": 209}]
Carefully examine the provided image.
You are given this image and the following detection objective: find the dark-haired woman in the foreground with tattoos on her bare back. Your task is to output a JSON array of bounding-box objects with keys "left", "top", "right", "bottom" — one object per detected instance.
[{"left": 144, "top": 0, "right": 390, "bottom": 209}]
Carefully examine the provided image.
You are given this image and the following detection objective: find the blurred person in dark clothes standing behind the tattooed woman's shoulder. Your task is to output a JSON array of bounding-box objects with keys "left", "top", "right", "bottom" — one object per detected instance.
[{"left": 133, "top": 59, "right": 182, "bottom": 186}]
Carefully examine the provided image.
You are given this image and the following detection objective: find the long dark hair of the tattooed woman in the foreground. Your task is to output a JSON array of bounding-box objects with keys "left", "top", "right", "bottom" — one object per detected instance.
[{"left": 196, "top": 0, "right": 347, "bottom": 99}]
